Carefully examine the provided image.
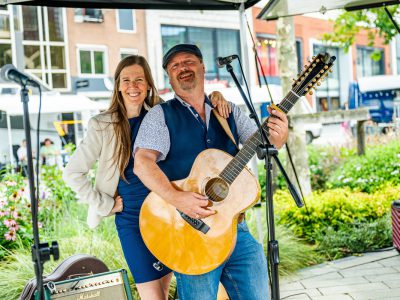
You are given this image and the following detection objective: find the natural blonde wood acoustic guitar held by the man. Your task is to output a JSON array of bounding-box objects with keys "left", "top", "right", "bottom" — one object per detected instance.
[{"left": 139, "top": 53, "right": 336, "bottom": 275}]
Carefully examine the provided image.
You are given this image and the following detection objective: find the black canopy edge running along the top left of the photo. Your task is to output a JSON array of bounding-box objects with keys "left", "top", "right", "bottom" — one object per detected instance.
[{"left": 0, "top": 0, "right": 260, "bottom": 10}]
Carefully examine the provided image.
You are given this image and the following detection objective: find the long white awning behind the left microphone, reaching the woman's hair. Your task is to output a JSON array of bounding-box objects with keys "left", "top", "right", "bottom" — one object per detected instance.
[{"left": 0, "top": 93, "right": 107, "bottom": 116}]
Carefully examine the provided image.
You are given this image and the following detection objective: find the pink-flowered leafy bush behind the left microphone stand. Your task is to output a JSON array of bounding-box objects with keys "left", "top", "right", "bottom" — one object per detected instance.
[{"left": 0, "top": 166, "right": 75, "bottom": 259}]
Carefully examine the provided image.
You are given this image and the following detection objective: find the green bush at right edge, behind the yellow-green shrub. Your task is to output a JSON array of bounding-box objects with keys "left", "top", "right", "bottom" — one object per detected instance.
[{"left": 328, "top": 140, "right": 400, "bottom": 193}]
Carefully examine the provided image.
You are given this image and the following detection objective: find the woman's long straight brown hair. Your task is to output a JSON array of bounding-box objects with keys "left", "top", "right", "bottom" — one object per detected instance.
[{"left": 105, "top": 55, "right": 160, "bottom": 181}]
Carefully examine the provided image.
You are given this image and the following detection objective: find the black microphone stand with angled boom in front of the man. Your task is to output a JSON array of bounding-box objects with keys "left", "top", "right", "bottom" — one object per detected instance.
[{"left": 226, "top": 63, "right": 304, "bottom": 300}]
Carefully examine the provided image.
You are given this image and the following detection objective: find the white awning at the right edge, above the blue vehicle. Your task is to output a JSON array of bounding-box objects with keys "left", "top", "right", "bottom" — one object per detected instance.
[{"left": 357, "top": 75, "right": 400, "bottom": 93}]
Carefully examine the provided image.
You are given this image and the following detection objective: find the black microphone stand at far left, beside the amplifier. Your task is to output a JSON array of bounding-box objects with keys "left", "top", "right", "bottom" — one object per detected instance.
[{"left": 20, "top": 81, "right": 59, "bottom": 300}]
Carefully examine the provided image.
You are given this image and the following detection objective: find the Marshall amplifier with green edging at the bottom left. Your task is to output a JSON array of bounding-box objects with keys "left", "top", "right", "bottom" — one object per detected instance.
[{"left": 35, "top": 269, "right": 133, "bottom": 300}]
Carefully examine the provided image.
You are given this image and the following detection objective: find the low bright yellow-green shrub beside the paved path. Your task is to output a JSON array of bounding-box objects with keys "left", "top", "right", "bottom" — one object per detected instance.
[{"left": 275, "top": 186, "right": 400, "bottom": 243}]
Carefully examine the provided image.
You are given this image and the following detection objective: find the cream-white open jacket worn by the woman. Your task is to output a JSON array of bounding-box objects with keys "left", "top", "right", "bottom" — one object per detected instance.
[{"left": 63, "top": 113, "right": 120, "bottom": 228}]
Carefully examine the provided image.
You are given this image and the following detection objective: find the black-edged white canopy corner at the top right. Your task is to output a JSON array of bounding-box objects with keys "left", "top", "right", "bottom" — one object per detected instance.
[{"left": 257, "top": 0, "right": 400, "bottom": 21}]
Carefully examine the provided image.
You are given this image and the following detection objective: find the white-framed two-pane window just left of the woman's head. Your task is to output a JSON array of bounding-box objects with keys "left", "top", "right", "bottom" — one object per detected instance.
[{"left": 78, "top": 48, "right": 106, "bottom": 75}]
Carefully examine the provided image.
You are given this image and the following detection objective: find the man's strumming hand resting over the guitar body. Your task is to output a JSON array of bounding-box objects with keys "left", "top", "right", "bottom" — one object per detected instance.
[{"left": 171, "top": 191, "right": 216, "bottom": 219}]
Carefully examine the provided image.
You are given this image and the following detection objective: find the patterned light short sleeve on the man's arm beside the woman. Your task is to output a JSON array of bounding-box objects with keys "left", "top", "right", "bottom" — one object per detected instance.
[{"left": 133, "top": 105, "right": 170, "bottom": 161}]
